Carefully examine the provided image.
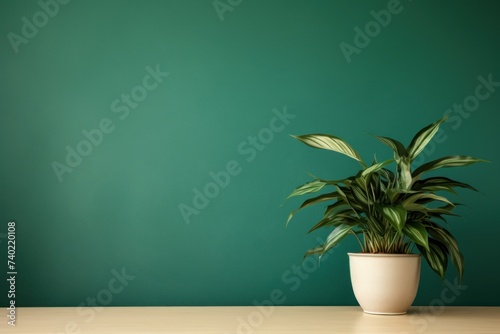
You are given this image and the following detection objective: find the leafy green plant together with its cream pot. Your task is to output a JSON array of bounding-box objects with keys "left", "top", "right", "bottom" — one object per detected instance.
[{"left": 287, "top": 117, "right": 485, "bottom": 314}]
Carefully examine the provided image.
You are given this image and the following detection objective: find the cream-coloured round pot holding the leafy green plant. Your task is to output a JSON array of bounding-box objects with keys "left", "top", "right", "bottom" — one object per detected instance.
[{"left": 348, "top": 253, "right": 420, "bottom": 315}]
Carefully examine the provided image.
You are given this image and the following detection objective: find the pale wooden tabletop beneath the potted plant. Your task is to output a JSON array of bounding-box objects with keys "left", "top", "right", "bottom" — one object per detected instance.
[{"left": 0, "top": 306, "right": 500, "bottom": 334}]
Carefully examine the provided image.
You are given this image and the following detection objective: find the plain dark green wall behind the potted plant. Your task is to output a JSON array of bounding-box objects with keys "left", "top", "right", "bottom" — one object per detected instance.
[{"left": 0, "top": 0, "right": 500, "bottom": 308}]
